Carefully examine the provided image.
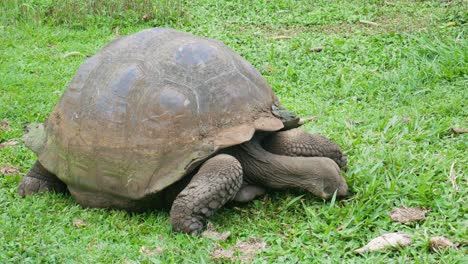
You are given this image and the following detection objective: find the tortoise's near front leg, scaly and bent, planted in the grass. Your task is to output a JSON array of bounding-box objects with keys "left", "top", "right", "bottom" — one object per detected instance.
[{"left": 170, "top": 154, "right": 242, "bottom": 234}]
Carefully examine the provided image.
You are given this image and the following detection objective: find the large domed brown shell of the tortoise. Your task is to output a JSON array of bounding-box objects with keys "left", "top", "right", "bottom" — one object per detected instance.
[{"left": 38, "top": 28, "right": 283, "bottom": 199}]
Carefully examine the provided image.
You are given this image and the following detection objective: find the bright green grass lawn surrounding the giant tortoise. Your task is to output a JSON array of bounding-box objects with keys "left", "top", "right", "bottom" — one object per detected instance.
[{"left": 0, "top": 0, "right": 468, "bottom": 263}]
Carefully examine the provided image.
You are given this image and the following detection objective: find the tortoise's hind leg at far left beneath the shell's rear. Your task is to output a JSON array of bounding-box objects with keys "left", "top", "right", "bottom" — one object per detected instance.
[{"left": 18, "top": 161, "right": 67, "bottom": 197}]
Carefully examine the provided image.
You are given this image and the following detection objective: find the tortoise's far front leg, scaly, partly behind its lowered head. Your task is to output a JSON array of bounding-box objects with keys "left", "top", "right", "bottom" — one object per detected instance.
[{"left": 262, "top": 128, "right": 348, "bottom": 170}]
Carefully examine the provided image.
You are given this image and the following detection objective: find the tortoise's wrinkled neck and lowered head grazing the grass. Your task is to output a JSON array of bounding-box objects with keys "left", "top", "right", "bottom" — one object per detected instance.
[{"left": 226, "top": 133, "right": 348, "bottom": 199}]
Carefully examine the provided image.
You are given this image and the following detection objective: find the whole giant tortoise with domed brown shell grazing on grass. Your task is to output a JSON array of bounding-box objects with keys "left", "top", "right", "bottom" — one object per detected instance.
[{"left": 18, "top": 28, "right": 348, "bottom": 234}]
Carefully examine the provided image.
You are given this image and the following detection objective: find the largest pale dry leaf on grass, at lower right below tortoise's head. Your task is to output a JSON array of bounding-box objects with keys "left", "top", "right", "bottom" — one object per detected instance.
[{"left": 354, "top": 232, "right": 413, "bottom": 253}]
